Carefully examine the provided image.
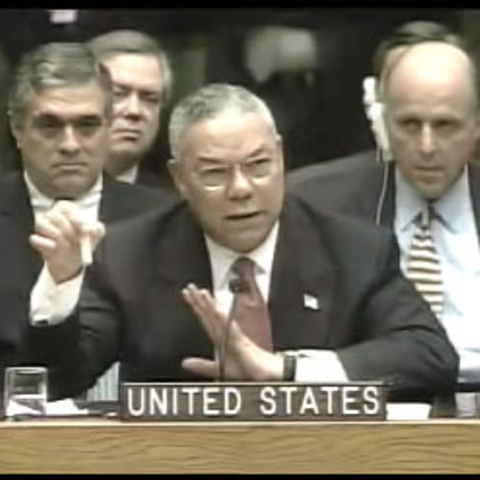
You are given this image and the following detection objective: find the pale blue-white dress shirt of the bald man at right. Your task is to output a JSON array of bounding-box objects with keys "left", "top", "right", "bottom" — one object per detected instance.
[{"left": 395, "top": 169, "right": 480, "bottom": 414}]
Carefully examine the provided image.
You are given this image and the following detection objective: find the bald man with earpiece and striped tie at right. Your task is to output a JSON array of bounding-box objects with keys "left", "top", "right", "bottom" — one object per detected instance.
[{"left": 290, "top": 34, "right": 480, "bottom": 416}]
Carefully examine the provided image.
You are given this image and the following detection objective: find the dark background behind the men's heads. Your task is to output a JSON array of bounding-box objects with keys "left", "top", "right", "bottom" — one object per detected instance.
[{"left": 0, "top": 8, "right": 469, "bottom": 175}]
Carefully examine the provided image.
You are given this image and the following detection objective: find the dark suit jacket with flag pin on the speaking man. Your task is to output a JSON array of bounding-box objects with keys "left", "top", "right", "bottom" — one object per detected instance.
[{"left": 27, "top": 195, "right": 457, "bottom": 402}]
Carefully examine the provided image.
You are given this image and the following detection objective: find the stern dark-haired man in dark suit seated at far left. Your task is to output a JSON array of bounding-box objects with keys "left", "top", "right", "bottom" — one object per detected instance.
[{"left": 0, "top": 43, "right": 172, "bottom": 402}]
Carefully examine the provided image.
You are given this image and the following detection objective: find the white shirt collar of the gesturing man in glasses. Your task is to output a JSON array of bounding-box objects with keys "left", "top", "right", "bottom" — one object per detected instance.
[{"left": 205, "top": 221, "right": 279, "bottom": 290}]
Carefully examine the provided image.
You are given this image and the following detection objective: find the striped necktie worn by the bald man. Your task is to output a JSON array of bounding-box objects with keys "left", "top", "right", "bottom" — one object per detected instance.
[{"left": 406, "top": 206, "right": 443, "bottom": 318}]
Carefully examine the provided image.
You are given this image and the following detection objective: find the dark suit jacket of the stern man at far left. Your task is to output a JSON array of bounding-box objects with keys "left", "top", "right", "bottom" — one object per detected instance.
[{"left": 0, "top": 172, "right": 172, "bottom": 378}]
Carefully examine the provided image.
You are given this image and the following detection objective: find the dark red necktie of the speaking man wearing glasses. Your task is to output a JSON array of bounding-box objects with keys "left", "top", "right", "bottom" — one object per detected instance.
[{"left": 230, "top": 257, "right": 273, "bottom": 351}]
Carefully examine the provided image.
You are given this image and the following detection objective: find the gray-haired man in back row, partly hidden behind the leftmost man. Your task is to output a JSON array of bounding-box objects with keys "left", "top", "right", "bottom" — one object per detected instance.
[{"left": 88, "top": 30, "right": 172, "bottom": 191}]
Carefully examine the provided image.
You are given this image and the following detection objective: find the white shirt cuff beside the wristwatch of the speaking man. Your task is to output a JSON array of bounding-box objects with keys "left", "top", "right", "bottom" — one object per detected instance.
[{"left": 288, "top": 350, "right": 349, "bottom": 383}]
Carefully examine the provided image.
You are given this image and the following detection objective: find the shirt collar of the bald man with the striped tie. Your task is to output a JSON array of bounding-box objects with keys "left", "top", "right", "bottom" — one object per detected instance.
[{"left": 395, "top": 168, "right": 471, "bottom": 231}]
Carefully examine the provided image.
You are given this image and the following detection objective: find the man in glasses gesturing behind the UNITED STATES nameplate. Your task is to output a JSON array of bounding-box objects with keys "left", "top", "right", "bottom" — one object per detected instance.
[{"left": 25, "top": 84, "right": 457, "bottom": 402}]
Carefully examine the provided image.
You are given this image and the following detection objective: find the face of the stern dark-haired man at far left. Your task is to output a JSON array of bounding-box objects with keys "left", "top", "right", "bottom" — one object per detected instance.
[{"left": 12, "top": 82, "right": 110, "bottom": 198}]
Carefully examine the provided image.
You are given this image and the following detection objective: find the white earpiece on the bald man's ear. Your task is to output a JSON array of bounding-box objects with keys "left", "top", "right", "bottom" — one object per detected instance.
[{"left": 363, "top": 77, "right": 392, "bottom": 161}]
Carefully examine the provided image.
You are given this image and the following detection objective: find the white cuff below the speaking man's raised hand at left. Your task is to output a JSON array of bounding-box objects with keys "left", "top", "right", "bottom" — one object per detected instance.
[{"left": 30, "top": 266, "right": 85, "bottom": 325}]
